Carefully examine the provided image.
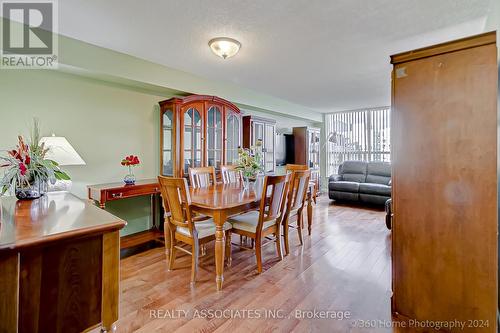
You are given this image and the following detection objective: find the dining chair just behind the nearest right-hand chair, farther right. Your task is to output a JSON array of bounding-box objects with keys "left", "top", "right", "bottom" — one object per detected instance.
[{"left": 283, "top": 170, "right": 311, "bottom": 255}]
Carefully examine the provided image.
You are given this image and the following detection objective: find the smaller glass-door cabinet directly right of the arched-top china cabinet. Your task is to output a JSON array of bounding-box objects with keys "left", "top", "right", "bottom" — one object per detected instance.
[{"left": 243, "top": 116, "right": 276, "bottom": 172}]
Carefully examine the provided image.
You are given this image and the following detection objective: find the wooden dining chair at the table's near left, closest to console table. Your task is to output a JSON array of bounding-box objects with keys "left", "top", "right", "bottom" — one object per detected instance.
[{"left": 158, "top": 176, "right": 231, "bottom": 284}]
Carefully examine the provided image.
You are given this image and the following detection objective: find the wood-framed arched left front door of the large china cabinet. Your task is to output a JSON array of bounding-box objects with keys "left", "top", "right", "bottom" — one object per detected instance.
[{"left": 180, "top": 103, "right": 205, "bottom": 176}]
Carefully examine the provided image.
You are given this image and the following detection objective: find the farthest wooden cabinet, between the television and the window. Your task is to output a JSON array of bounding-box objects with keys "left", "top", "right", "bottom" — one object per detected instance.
[{"left": 293, "top": 127, "right": 320, "bottom": 170}]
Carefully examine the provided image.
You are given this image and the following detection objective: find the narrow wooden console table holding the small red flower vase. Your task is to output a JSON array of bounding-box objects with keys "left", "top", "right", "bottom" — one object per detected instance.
[{"left": 87, "top": 179, "right": 163, "bottom": 249}]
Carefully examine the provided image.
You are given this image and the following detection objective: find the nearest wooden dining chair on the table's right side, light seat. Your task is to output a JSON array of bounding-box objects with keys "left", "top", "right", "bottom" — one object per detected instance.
[{"left": 228, "top": 174, "right": 290, "bottom": 273}]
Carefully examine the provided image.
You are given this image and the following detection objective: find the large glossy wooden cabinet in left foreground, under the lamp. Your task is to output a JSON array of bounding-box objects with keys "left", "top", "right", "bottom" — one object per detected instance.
[{"left": 0, "top": 192, "right": 126, "bottom": 333}]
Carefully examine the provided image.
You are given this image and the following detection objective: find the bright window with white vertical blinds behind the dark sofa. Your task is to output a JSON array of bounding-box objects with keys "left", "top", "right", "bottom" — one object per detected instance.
[{"left": 326, "top": 107, "right": 391, "bottom": 175}]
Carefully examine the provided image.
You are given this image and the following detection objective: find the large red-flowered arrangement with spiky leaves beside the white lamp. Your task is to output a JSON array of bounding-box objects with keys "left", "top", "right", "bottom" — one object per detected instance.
[{"left": 0, "top": 119, "right": 70, "bottom": 199}]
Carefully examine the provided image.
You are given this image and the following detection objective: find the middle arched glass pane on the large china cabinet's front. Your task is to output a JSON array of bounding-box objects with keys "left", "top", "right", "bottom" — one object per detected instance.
[{"left": 207, "top": 106, "right": 223, "bottom": 169}]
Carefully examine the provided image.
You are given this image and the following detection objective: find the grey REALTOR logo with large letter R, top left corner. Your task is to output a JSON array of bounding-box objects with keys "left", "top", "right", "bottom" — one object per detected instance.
[{"left": 0, "top": 0, "right": 57, "bottom": 69}]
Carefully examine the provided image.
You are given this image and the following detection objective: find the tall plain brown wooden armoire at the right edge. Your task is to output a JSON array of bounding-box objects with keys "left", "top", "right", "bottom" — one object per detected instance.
[{"left": 391, "top": 32, "right": 498, "bottom": 332}]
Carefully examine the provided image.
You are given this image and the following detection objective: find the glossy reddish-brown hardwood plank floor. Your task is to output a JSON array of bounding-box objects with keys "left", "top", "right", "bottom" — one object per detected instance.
[{"left": 107, "top": 196, "right": 392, "bottom": 332}]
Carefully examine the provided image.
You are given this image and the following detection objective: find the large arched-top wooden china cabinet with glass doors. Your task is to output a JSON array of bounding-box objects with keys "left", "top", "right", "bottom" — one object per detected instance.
[{"left": 159, "top": 95, "right": 241, "bottom": 177}]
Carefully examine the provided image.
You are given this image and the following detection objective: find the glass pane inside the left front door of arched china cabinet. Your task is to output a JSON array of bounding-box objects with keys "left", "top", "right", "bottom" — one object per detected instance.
[{"left": 184, "top": 107, "right": 202, "bottom": 175}]
